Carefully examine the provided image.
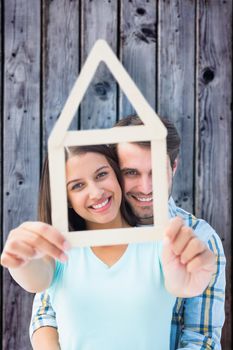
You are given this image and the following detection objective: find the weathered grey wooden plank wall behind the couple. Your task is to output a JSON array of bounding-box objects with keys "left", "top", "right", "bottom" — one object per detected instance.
[{"left": 0, "top": 0, "right": 232, "bottom": 350}]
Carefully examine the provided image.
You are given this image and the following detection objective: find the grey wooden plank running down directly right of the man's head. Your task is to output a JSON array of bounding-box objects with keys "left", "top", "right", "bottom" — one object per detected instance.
[{"left": 157, "top": 0, "right": 195, "bottom": 212}]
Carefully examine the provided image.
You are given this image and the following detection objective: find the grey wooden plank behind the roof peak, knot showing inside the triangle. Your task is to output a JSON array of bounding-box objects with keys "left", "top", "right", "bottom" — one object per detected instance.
[{"left": 80, "top": 0, "right": 117, "bottom": 129}]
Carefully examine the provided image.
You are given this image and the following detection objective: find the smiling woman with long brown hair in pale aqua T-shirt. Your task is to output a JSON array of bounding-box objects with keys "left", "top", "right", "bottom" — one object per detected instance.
[{"left": 2, "top": 146, "right": 213, "bottom": 350}]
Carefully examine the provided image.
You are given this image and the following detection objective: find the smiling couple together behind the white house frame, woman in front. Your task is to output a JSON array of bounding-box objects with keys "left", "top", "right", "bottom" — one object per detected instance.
[{"left": 2, "top": 117, "right": 225, "bottom": 350}]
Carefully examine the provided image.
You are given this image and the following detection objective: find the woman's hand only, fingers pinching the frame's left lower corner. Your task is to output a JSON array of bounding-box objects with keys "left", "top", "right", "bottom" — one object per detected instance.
[{"left": 1, "top": 222, "right": 69, "bottom": 269}]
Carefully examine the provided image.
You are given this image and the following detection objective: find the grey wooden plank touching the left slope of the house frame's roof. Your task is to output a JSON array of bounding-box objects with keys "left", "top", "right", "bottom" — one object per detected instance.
[{"left": 42, "top": 0, "right": 80, "bottom": 151}]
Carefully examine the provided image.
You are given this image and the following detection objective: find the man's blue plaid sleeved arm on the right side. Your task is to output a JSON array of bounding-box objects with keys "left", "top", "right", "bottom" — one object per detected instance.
[{"left": 171, "top": 225, "right": 226, "bottom": 350}]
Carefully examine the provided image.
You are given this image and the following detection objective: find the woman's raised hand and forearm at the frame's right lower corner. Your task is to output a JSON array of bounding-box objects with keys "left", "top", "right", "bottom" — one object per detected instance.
[{"left": 162, "top": 217, "right": 216, "bottom": 298}]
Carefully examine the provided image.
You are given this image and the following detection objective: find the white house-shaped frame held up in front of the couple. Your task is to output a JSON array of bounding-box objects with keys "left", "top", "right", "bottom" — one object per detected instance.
[{"left": 48, "top": 40, "right": 168, "bottom": 247}]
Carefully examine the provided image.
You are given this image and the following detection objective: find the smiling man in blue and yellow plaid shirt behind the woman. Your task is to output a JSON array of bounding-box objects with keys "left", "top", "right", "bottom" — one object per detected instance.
[{"left": 31, "top": 116, "right": 225, "bottom": 350}]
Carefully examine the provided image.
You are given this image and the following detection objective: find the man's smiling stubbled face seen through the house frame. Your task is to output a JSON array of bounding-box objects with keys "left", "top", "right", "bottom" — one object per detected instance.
[{"left": 117, "top": 142, "right": 172, "bottom": 224}]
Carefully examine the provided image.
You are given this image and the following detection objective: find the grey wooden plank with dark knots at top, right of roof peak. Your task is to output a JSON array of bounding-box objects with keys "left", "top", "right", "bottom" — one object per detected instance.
[{"left": 119, "top": 0, "right": 157, "bottom": 118}]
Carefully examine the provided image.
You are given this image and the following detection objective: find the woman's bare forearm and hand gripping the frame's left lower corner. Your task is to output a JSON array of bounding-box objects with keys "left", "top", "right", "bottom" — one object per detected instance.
[{"left": 1, "top": 222, "right": 69, "bottom": 292}]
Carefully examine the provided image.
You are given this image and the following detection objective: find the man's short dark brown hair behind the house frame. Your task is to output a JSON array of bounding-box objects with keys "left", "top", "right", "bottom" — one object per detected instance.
[{"left": 115, "top": 114, "right": 180, "bottom": 168}]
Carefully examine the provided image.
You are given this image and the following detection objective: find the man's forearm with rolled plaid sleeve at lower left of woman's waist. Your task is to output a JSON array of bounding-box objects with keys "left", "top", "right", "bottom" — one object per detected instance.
[{"left": 30, "top": 291, "right": 60, "bottom": 350}]
